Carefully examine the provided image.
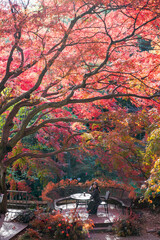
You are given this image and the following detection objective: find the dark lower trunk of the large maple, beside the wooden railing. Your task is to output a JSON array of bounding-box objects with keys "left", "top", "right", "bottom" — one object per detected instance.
[{"left": 0, "top": 165, "right": 7, "bottom": 214}]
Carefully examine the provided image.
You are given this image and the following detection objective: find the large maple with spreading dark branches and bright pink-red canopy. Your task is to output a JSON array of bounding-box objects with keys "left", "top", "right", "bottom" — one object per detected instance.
[{"left": 0, "top": 0, "right": 160, "bottom": 211}]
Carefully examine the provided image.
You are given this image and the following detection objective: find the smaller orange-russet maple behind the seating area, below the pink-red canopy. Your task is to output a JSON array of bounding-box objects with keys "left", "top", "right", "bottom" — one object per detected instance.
[{"left": 82, "top": 108, "right": 159, "bottom": 182}]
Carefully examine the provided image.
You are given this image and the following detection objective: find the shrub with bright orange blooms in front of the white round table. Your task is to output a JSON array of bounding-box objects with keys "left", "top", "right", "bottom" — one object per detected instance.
[{"left": 30, "top": 211, "right": 93, "bottom": 240}]
